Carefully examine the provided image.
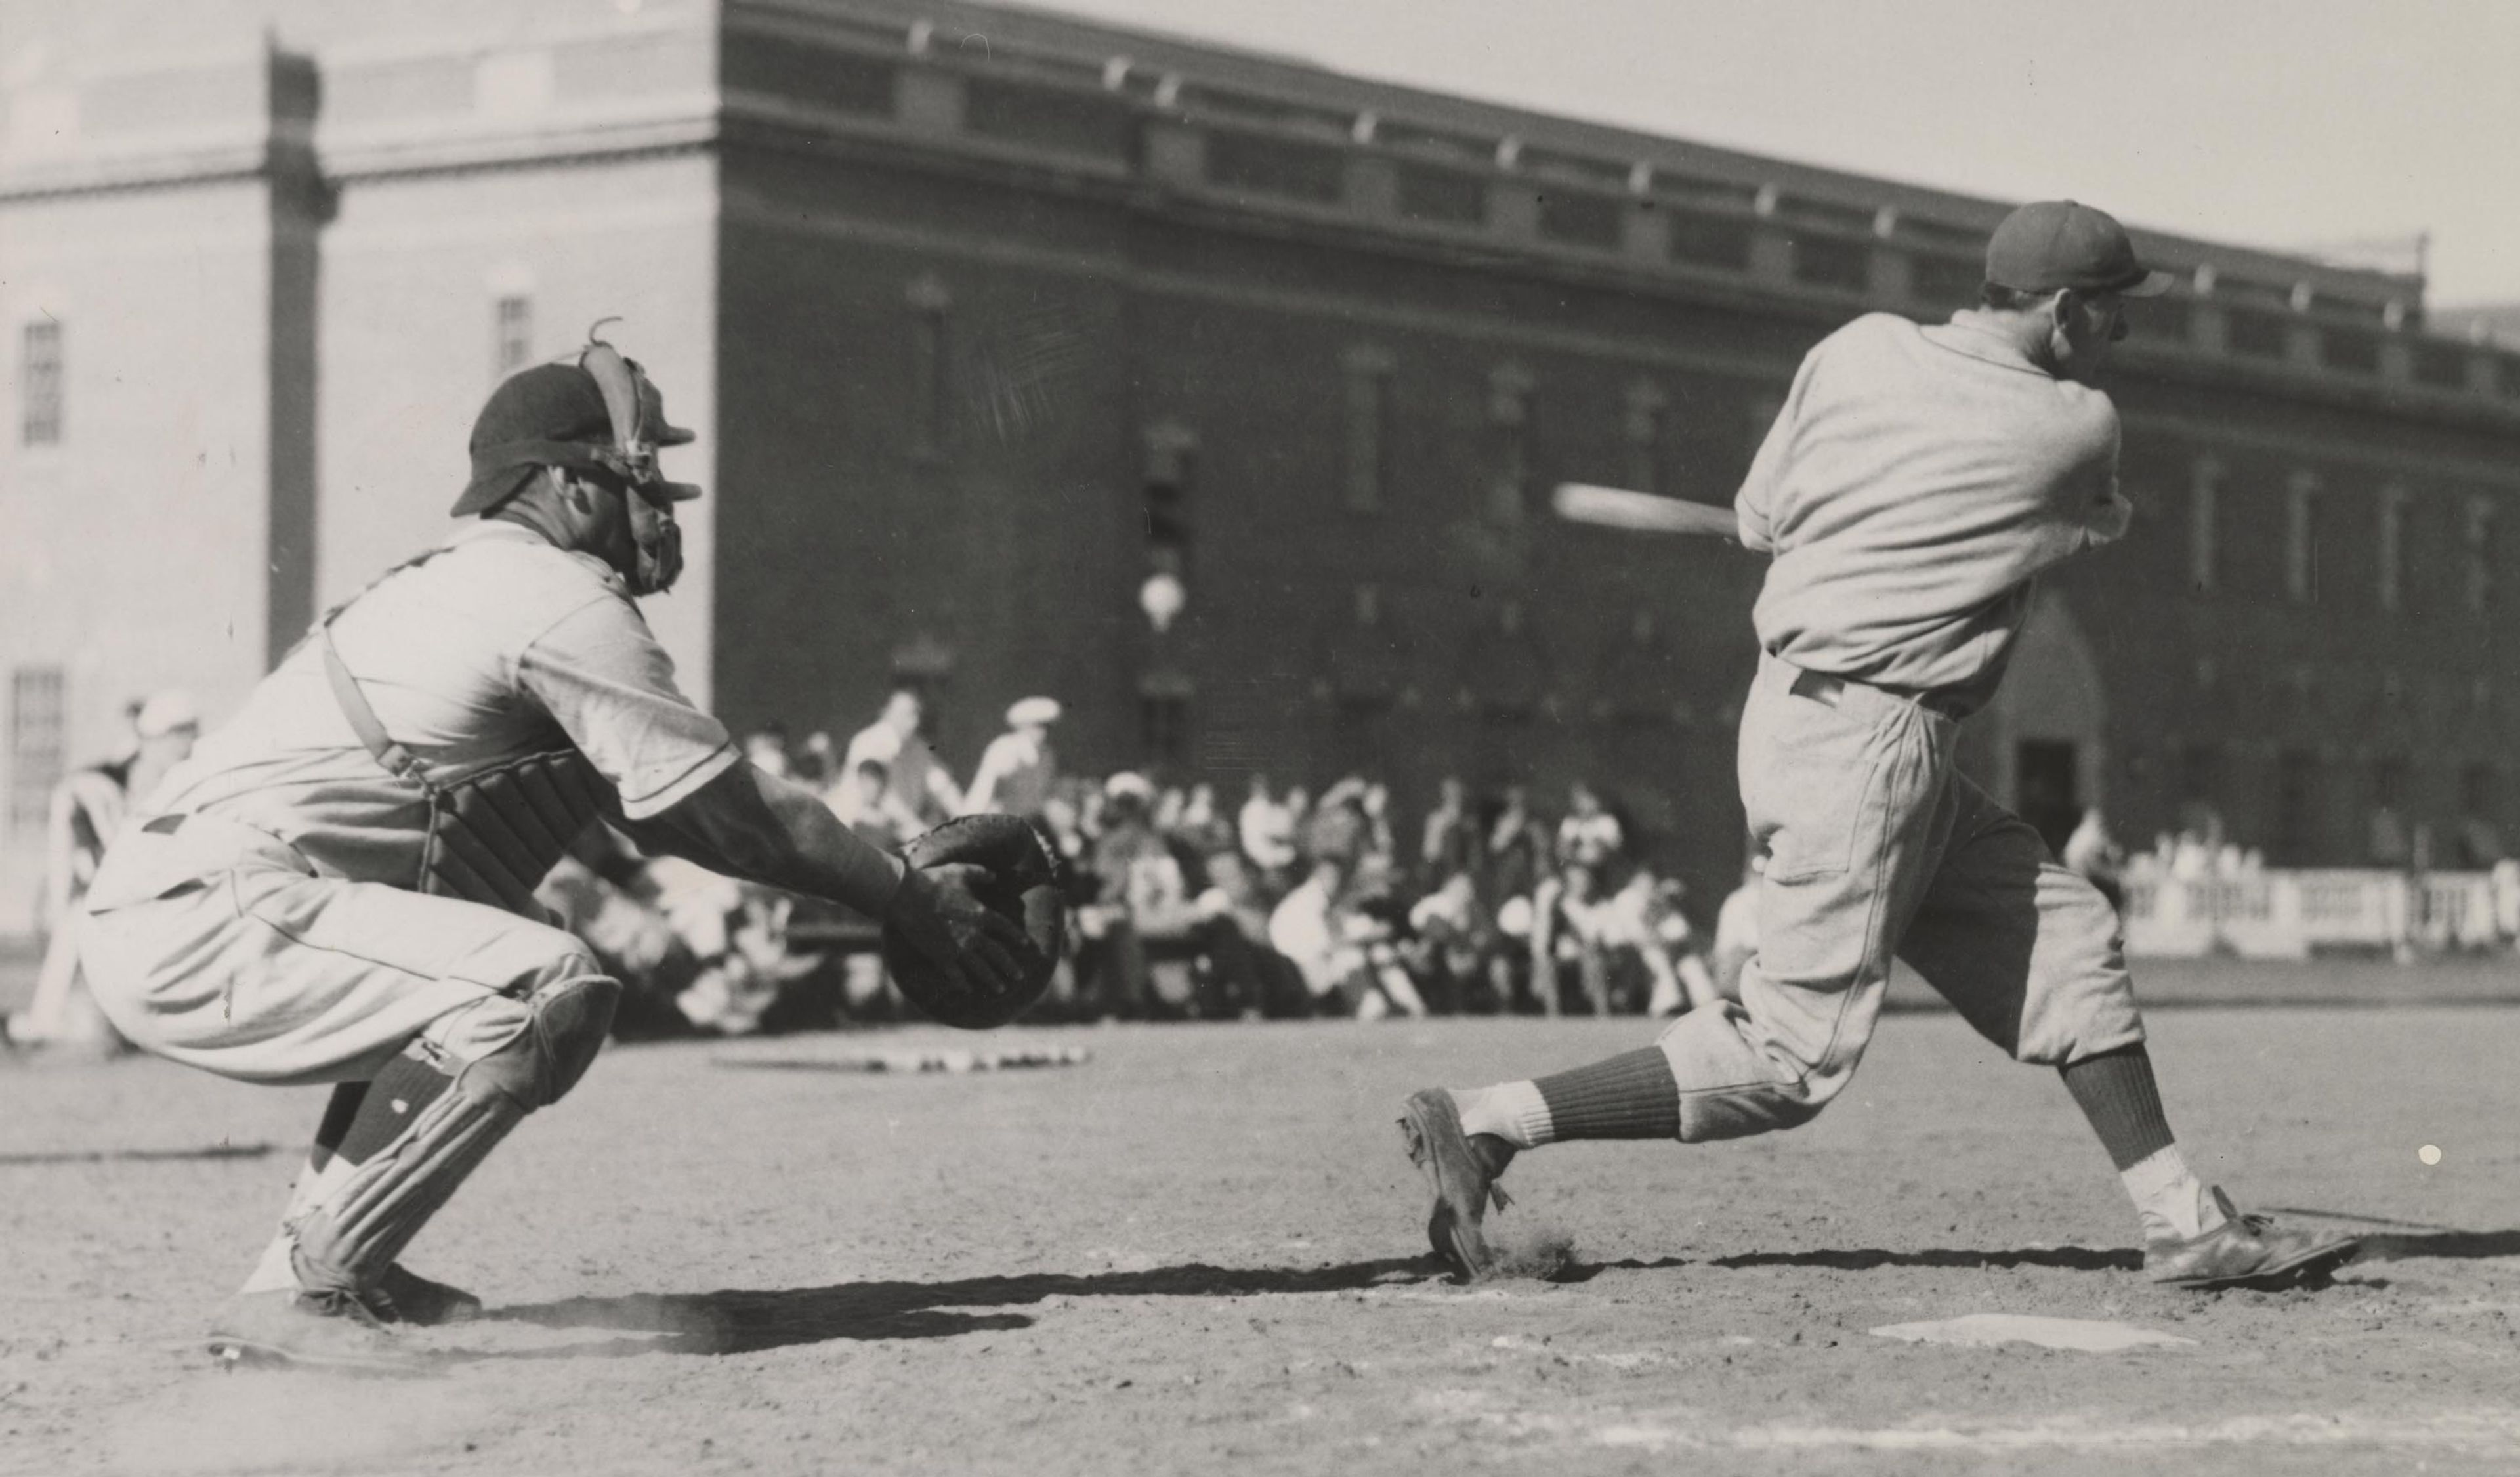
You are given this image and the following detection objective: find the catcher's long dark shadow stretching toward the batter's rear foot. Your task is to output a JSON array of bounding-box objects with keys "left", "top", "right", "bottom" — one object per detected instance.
[{"left": 479, "top": 1258, "right": 1441, "bottom": 1359}]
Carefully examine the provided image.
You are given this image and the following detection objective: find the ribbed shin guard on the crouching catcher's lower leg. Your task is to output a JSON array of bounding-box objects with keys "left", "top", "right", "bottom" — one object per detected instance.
[{"left": 290, "top": 960, "right": 620, "bottom": 1293}]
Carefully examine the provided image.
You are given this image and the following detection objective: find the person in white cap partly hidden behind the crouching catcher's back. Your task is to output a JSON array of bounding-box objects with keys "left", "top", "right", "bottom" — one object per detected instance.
[{"left": 5, "top": 688, "right": 201, "bottom": 1051}]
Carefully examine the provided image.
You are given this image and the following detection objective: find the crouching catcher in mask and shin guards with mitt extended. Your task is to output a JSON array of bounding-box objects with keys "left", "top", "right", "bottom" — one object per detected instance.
[{"left": 81, "top": 343, "right": 1059, "bottom": 1371}]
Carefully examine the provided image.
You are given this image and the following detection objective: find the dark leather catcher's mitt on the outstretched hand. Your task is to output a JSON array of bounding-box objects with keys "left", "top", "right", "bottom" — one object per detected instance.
[{"left": 885, "top": 817, "right": 1068, "bottom": 1031}]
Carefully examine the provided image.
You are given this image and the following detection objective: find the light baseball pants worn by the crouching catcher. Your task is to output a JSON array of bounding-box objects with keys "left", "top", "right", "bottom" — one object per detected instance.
[{"left": 81, "top": 814, "right": 605, "bottom": 1084}]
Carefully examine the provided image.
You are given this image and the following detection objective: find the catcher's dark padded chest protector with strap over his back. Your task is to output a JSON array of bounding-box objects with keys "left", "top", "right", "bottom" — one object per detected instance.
[{"left": 315, "top": 620, "right": 610, "bottom": 918}]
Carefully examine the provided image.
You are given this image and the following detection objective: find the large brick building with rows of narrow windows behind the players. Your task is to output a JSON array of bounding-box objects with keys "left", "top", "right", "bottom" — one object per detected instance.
[{"left": 0, "top": 0, "right": 2520, "bottom": 928}]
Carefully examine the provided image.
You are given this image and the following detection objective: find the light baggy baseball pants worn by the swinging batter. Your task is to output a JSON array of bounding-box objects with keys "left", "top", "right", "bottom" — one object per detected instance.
[{"left": 1658, "top": 655, "right": 2145, "bottom": 1142}]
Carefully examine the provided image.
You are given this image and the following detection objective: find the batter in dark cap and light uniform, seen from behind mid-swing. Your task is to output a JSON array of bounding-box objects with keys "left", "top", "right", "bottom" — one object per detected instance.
[{"left": 1401, "top": 202, "right": 2354, "bottom": 1288}]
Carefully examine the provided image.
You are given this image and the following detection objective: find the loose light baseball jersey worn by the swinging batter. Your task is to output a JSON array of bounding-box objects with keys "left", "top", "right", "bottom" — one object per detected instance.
[{"left": 1734, "top": 312, "right": 2130, "bottom": 708}]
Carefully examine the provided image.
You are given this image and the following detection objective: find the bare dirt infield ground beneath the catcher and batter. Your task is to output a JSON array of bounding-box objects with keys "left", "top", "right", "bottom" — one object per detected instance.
[{"left": 0, "top": 1008, "right": 2520, "bottom": 1477}]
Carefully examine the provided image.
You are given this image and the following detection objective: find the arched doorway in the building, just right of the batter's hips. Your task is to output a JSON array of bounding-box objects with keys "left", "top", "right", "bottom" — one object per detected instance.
[{"left": 1961, "top": 589, "right": 2109, "bottom": 849}]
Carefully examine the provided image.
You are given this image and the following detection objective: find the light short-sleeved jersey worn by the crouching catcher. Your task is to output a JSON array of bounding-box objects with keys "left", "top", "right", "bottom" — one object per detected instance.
[{"left": 108, "top": 519, "right": 738, "bottom": 882}]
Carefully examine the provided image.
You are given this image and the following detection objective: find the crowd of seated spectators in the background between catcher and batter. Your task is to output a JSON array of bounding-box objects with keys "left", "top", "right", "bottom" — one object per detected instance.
[{"left": 544, "top": 688, "right": 1754, "bottom": 1033}]
